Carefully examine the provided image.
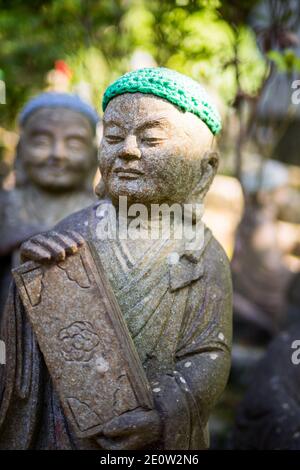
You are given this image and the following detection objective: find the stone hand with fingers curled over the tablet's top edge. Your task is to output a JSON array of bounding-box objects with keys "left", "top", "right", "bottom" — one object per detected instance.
[{"left": 21, "top": 230, "right": 84, "bottom": 262}]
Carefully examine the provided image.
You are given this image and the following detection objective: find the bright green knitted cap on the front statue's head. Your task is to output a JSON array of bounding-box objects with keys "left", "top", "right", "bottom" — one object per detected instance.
[{"left": 102, "top": 67, "right": 222, "bottom": 134}]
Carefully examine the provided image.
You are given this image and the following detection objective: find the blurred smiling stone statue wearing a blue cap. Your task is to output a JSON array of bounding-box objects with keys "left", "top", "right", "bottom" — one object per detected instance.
[{"left": 0, "top": 92, "right": 98, "bottom": 314}]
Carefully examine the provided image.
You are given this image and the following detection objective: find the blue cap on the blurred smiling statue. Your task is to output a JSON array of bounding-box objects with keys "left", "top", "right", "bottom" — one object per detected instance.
[{"left": 19, "top": 92, "right": 99, "bottom": 127}]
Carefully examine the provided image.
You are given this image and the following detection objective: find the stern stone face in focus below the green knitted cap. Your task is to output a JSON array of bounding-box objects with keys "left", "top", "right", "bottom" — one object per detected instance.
[{"left": 99, "top": 93, "right": 213, "bottom": 204}]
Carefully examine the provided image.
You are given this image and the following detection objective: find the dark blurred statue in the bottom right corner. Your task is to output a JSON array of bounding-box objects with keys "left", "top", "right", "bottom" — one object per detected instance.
[{"left": 233, "top": 273, "right": 300, "bottom": 450}]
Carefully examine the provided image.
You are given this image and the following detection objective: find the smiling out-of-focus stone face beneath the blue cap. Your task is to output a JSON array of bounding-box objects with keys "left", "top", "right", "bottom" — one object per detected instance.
[{"left": 19, "top": 108, "right": 95, "bottom": 191}]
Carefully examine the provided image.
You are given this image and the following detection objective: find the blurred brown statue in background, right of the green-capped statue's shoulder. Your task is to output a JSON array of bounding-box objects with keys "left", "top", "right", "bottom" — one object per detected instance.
[{"left": 232, "top": 161, "right": 290, "bottom": 345}]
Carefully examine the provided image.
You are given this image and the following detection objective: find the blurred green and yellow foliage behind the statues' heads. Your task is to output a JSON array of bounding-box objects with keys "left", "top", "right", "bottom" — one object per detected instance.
[{"left": 0, "top": 0, "right": 299, "bottom": 126}]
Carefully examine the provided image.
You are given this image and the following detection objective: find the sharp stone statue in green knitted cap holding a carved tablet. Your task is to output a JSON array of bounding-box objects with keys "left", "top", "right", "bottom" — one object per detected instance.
[{"left": 0, "top": 68, "right": 232, "bottom": 449}]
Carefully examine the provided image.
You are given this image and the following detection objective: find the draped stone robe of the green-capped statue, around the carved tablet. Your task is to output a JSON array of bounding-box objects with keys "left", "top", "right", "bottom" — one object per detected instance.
[{"left": 0, "top": 201, "right": 232, "bottom": 449}]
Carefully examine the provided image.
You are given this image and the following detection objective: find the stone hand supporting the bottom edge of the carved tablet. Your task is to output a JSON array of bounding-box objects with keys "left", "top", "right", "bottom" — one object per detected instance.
[{"left": 96, "top": 409, "right": 161, "bottom": 450}]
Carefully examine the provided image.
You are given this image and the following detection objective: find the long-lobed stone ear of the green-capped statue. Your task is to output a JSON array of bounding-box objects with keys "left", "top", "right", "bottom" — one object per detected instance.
[{"left": 193, "top": 150, "right": 219, "bottom": 201}]
